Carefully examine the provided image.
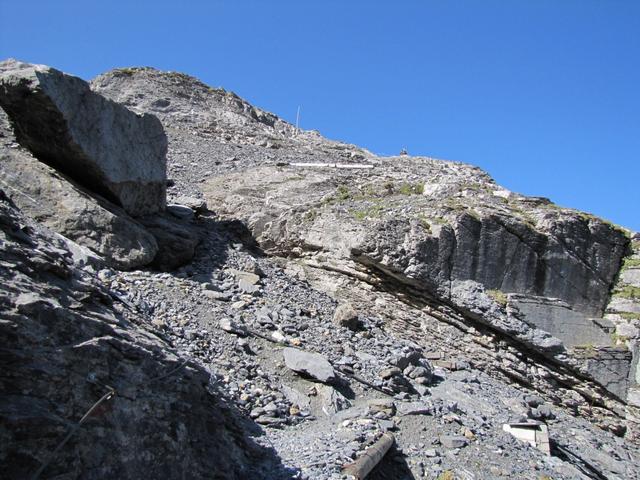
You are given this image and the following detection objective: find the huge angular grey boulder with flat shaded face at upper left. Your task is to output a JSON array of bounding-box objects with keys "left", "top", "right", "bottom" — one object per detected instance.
[{"left": 0, "top": 60, "right": 167, "bottom": 215}]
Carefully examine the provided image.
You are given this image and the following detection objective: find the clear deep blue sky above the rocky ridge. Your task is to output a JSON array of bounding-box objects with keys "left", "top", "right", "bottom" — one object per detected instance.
[{"left": 0, "top": 0, "right": 640, "bottom": 230}]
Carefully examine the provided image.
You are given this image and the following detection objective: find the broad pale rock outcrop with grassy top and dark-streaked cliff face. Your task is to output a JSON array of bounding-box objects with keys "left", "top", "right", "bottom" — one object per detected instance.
[{"left": 205, "top": 147, "right": 630, "bottom": 398}]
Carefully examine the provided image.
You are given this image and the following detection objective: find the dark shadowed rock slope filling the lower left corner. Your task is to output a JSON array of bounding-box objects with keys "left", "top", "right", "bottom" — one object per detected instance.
[{"left": 0, "top": 201, "right": 297, "bottom": 480}]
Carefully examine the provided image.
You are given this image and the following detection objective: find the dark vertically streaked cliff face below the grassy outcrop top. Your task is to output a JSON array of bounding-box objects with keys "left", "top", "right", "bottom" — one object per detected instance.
[{"left": 356, "top": 212, "right": 629, "bottom": 315}]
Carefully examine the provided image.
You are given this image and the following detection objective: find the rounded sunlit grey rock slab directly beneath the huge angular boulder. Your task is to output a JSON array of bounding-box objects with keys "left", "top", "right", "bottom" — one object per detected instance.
[{"left": 0, "top": 109, "right": 158, "bottom": 270}]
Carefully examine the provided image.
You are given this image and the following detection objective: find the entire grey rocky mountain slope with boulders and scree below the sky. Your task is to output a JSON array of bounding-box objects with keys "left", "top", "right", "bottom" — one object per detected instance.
[{"left": 0, "top": 61, "right": 640, "bottom": 479}]
